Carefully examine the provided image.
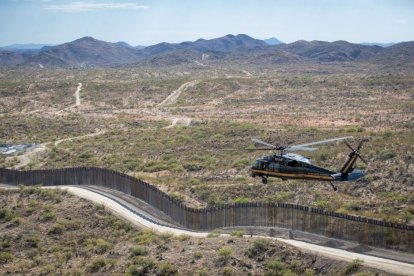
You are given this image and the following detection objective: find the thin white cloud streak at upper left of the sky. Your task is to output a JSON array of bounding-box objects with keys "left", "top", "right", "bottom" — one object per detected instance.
[{"left": 44, "top": 2, "right": 149, "bottom": 12}]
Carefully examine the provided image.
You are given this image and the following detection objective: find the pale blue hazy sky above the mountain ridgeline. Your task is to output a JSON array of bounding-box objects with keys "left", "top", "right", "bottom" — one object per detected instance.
[{"left": 0, "top": 0, "right": 414, "bottom": 46}]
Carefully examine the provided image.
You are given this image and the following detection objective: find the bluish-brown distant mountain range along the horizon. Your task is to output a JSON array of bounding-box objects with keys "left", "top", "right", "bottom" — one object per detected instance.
[{"left": 0, "top": 34, "right": 414, "bottom": 68}]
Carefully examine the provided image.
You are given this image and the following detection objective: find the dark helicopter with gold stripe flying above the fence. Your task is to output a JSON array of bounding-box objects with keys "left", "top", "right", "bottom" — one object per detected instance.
[{"left": 249, "top": 136, "right": 367, "bottom": 191}]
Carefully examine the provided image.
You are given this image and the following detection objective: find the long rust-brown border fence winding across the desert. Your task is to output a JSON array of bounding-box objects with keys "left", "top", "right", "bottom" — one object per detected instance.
[{"left": 0, "top": 167, "right": 414, "bottom": 253}]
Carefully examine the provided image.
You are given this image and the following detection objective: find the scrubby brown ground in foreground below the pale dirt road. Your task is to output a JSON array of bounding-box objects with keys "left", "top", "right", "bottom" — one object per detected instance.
[{"left": 0, "top": 187, "right": 383, "bottom": 275}]
